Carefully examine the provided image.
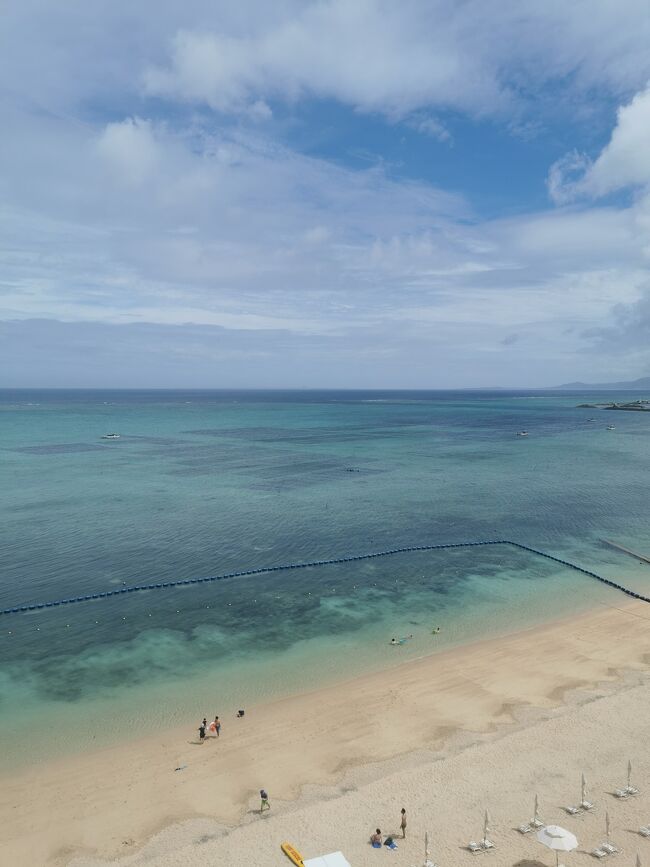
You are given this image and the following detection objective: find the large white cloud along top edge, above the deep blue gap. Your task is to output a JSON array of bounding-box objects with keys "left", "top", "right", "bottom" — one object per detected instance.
[{"left": 144, "top": 0, "right": 650, "bottom": 119}]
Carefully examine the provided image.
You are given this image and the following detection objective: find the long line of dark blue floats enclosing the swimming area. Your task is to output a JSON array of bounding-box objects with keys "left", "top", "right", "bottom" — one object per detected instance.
[{"left": 0, "top": 539, "right": 650, "bottom": 615}]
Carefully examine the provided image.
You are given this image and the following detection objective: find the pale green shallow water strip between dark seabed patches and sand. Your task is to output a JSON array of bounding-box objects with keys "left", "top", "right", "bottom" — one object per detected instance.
[{"left": 0, "top": 568, "right": 628, "bottom": 777}]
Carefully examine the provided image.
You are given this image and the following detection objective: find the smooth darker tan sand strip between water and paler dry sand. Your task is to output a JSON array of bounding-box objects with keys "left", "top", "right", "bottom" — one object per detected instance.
[{"left": 0, "top": 602, "right": 650, "bottom": 865}]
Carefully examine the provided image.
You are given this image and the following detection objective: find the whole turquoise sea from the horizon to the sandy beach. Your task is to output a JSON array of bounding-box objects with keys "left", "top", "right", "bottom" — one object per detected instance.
[{"left": 0, "top": 391, "right": 650, "bottom": 764}]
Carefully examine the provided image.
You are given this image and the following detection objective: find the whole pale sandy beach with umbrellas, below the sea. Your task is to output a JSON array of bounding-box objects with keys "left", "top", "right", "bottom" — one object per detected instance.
[{"left": 0, "top": 599, "right": 650, "bottom": 867}]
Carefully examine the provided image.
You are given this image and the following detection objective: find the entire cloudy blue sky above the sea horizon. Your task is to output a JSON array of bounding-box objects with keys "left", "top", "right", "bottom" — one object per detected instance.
[{"left": 0, "top": 0, "right": 650, "bottom": 388}]
